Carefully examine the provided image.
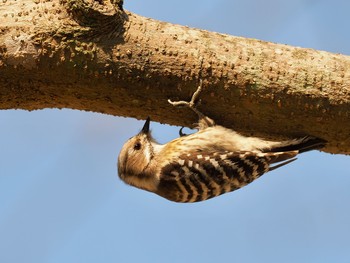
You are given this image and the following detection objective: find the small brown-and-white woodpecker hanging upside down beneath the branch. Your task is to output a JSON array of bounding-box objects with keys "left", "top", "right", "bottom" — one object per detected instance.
[{"left": 118, "top": 82, "right": 326, "bottom": 203}]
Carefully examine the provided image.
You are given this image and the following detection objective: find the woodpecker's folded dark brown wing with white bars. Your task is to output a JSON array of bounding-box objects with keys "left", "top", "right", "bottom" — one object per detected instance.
[{"left": 157, "top": 151, "right": 298, "bottom": 202}]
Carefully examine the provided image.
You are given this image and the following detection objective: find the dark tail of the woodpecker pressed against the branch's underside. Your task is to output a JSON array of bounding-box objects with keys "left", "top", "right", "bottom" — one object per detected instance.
[{"left": 266, "top": 136, "right": 327, "bottom": 153}]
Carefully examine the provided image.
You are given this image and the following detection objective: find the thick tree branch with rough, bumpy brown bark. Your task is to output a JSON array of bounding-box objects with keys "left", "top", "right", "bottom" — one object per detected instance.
[{"left": 0, "top": 0, "right": 350, "bottom": 154}]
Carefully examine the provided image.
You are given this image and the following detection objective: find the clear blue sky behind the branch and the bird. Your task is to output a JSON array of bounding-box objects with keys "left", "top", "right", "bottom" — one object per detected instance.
[{"left": 0, "top": 0, "right": 350, "bottom": 263}]
